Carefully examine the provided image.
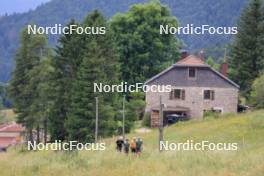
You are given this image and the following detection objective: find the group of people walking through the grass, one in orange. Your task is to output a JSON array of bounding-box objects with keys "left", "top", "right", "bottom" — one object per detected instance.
[{"left": 116, "top": 136, "right": 143, "bottom": 155}]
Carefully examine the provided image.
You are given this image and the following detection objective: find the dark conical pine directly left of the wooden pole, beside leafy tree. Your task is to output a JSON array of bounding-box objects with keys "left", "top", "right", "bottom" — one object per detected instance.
[{"left": 67, "top": 42, "right": 103, "bottom": 141}]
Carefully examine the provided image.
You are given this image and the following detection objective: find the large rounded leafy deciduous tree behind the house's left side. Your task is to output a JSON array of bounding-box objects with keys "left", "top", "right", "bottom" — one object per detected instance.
[{"left": 110, "top": 2, "right": 178, "bottom": 84}]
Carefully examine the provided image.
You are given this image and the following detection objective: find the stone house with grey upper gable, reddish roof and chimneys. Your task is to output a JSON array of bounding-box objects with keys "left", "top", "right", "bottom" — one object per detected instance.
[{"left": 145, "top": 53, "right": 239, "bottom": 127}]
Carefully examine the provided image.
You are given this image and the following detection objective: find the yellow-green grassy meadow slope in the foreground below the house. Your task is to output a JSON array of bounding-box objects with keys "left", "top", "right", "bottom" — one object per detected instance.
[{"left": 0, "top": 110, "right": 264, "bottom": 176}]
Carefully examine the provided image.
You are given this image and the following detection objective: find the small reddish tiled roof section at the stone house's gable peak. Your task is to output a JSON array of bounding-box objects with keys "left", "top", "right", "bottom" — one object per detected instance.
[{"left": 175, "top": 55, "right": 208, "bottom": 67}]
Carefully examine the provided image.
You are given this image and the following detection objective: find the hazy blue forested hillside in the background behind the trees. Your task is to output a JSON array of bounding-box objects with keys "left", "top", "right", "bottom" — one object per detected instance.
[{"left": 0, "top": 0, "right": 250, "bottom": 82}]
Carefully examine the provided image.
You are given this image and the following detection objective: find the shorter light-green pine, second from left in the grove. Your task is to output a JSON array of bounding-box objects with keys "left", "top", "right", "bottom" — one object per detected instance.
[{"left": 28, "top": 57, "right": 54, "bottom": 143}]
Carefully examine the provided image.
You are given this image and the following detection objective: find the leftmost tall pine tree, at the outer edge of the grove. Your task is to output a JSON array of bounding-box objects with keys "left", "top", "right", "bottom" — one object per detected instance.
[{"left": 8, "top": 26, "right": 47, "bottom": 140}]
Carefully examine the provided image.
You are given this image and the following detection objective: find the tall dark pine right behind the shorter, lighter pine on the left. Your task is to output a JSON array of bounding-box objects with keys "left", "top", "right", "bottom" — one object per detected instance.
[{"left": 49, "top": 20, "right": 85, "bottom": 140}]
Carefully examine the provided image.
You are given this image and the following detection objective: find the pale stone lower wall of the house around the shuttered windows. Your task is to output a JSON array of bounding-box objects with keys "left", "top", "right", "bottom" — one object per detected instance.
[{"left": 146, "top": 87, "right": 238, "bottom": 127}]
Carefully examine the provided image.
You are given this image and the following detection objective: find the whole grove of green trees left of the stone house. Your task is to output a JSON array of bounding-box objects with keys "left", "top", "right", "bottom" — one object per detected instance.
[{"left": 8, "top": 2, "right": 179, "bottom": 142}]
